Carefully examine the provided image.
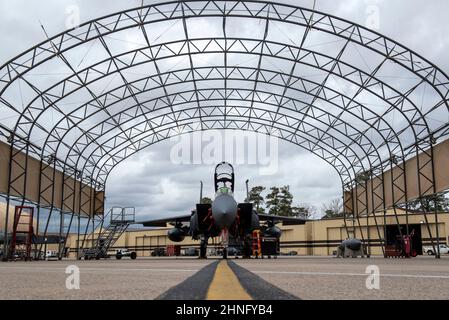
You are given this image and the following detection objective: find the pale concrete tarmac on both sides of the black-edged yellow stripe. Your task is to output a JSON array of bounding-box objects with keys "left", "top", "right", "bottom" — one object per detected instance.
[{"left": 0, "top": 256, "right": 449, "bottom": 299}]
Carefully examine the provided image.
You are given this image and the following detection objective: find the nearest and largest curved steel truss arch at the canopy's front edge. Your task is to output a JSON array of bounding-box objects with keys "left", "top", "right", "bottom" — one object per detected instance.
[{"left": 0, "top": 1, "right": 448, "bottom": 114}]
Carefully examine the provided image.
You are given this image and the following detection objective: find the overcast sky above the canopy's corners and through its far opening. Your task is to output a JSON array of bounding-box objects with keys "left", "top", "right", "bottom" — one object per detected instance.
[{"left": 0, "top": 0, "right": 449, "bottom": 220}]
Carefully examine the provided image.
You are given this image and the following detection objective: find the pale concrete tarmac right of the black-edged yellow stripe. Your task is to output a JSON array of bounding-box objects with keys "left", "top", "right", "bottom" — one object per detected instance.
[{"left": 233, "top": 256, "right": 449, "bottom": 300}]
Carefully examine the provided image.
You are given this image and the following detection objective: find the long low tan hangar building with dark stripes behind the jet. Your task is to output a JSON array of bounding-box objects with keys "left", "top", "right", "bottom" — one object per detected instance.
[{"left": 67, "top": 211, "right": 449, "bottom": 257}]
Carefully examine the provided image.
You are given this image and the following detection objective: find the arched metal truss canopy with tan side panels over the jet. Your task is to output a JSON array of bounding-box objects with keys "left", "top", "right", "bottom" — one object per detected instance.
[{"left": 0, "top": 1, "right": 449, "bottom": 258}]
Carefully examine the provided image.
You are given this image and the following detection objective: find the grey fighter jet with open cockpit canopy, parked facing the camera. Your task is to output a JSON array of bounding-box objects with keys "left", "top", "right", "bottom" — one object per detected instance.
[{"left": 139, "top": 162, "right": 305, "bottom": 259}]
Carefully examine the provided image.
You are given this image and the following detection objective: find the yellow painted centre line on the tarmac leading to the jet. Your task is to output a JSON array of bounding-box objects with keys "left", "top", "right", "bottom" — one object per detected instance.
[{"left": 206, "top": 260, "right": 252, "bottom": 300}]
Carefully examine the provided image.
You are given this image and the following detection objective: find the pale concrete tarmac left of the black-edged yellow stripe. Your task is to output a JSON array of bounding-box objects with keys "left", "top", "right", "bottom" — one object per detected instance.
[{"left": 0, "top": 258, "right": 212, "bottom": 300}]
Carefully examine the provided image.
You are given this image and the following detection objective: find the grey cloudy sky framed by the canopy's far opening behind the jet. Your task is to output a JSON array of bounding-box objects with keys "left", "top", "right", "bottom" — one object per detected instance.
[{"left": 106, "top": 135, "right": 341, "bottom": 220}]
